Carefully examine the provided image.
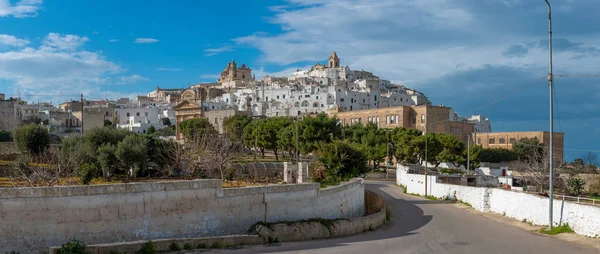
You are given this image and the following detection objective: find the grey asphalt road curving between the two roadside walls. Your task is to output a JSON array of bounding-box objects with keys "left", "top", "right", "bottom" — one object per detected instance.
[{"left": 202, "top": 181, "right": 598, "bottom": 254}]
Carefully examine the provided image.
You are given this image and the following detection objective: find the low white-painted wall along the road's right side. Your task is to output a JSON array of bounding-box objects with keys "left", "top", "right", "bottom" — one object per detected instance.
[{"left": 396, "top": 168, "right": 600, "bottom": 237}]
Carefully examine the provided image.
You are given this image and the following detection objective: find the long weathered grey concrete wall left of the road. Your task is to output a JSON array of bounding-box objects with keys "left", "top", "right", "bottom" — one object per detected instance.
[{"left": 0, "top": 179, "right": 364, "bottom": 253}]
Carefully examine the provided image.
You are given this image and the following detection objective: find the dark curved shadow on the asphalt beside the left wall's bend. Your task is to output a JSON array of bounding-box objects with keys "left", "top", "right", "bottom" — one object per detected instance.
[{"left": 226, "top": 182, "right": 435, "bottom": 253}]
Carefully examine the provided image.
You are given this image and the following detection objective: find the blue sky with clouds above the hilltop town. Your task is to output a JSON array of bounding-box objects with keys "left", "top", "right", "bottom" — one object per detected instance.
[{"left": 0, "top": 0, "right": 600, "bottom": 159}]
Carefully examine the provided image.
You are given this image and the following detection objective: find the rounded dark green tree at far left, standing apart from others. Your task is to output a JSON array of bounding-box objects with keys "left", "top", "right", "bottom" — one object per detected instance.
[{"left": 13, "top": 124, "right": 50, "bottom": 154}]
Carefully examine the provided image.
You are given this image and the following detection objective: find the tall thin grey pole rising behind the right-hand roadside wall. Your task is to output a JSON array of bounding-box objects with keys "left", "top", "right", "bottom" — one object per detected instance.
[{"left": 545, "top": 0, "right": 554, "bottom": 229}]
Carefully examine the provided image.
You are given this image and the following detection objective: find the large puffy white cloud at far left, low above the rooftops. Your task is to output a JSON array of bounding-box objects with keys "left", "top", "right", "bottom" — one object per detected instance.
[{"left": 0, "top": 33, "right": 149, "bottom": 98}]
